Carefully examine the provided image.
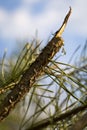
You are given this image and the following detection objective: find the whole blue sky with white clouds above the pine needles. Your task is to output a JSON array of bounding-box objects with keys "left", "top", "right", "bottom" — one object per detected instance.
[{"left": 0, "top": 0, "right": 87, "bottom": 60}]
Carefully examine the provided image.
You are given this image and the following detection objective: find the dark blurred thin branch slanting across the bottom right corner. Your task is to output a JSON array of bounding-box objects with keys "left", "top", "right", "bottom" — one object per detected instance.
[{"left": 26, "top": 104, "right": 87, "bottom": 130}]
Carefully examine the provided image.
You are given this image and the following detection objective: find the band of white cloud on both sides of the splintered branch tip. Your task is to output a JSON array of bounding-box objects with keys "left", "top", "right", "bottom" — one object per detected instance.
[{"left": 0, "top": 0, "right": 87, "bottom": 39}]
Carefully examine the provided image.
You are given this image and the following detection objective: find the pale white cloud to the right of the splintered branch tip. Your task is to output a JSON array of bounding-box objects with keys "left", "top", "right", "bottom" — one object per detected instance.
[{"left": 71, "top": 0, "right": 87, "bottom": 37}]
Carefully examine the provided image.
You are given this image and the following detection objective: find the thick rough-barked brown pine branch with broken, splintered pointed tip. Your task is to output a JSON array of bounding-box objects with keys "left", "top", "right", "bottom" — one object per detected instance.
[{"left": 0, "top": 8, "right": 71, "bottom": 121}]
